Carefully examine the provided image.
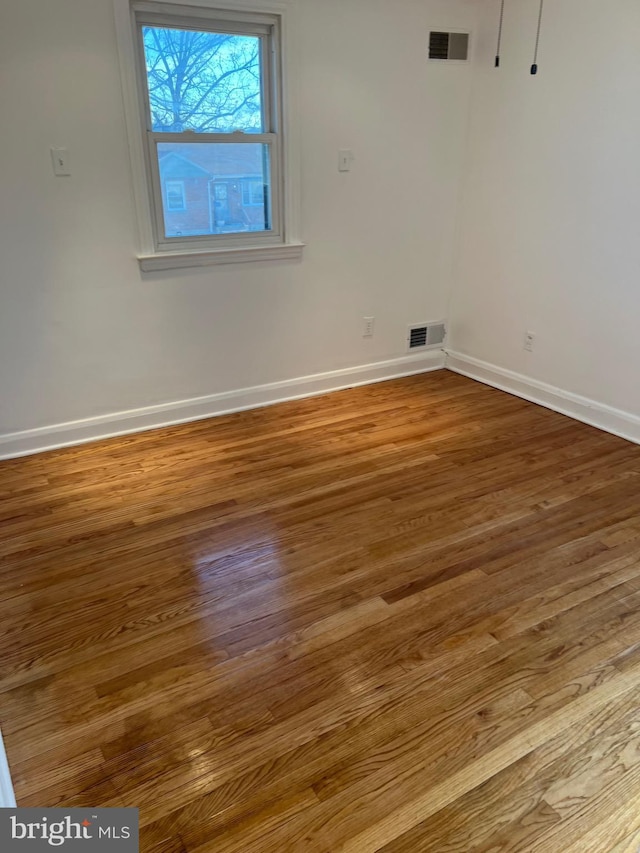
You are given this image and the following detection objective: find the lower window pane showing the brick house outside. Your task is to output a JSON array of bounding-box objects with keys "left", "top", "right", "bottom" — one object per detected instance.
[{"left": 158, "top": 142, "right": 271, "bottom": 238}]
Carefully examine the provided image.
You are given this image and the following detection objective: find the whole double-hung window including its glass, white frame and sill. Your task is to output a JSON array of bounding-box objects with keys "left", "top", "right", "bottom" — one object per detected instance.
[{"left": 115, "top": 0, "right": 301, "bottom": 269}]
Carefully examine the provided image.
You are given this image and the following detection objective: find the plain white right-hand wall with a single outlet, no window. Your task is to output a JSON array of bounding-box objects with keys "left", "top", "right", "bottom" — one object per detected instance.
[{"left": 450, "top": 0, "right": 640, "bottom": 422}]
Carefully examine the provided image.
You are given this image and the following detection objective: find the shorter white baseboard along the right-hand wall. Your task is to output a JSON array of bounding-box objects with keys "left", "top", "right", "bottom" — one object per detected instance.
[{"left": 446, "top": 351, "right": 640, "bottom": 444}]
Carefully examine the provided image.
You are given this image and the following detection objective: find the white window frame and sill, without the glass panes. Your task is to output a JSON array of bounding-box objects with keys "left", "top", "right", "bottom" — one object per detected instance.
[{"left": 114, "top": 0, "right": 303, "bottom": 272}]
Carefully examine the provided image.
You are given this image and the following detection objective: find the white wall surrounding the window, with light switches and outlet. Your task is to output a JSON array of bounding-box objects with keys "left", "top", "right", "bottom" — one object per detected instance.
[{"left": 0, "top": 0, "right": 476, "bottom": 437}]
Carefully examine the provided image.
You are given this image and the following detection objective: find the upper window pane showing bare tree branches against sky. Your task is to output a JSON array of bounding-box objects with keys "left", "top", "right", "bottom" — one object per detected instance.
[{"left": 142, "top": 26, "right": 264, "bottom": 133}]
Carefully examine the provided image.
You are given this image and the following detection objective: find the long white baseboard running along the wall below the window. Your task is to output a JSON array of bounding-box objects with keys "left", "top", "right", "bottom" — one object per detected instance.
[{"left": 0, "top": 350, "right": 445, "bottom": 460}]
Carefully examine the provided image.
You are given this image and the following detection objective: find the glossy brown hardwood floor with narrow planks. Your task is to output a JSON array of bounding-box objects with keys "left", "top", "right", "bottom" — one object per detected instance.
[{"left": 0, "top": 371, "right": 640, "bottom": 853}]
